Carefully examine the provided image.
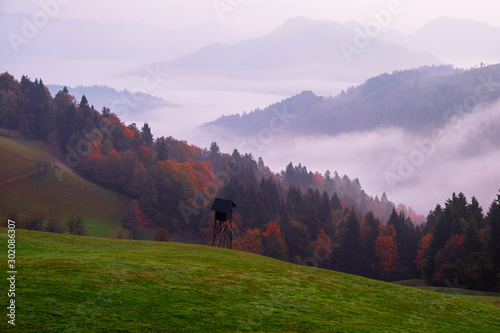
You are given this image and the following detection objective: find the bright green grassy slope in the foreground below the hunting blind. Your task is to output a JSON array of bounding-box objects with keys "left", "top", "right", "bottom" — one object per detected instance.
[{"left": 0, "top": 228, "right": 500, "bottom": 332}]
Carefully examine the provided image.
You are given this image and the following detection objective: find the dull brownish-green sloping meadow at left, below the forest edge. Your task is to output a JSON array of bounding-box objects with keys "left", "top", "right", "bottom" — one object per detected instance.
[{"left": 0, "top": 137, "right": 127, "bottom": 237}]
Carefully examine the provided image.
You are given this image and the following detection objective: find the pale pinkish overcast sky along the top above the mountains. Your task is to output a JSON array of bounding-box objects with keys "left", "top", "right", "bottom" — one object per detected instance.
[{"left": 0, "top": 0, "right": 500, "bottom": 34}]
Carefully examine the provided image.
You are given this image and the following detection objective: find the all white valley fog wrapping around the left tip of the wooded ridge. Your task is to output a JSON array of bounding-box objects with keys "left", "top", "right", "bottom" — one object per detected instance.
[{"left": 102, "top": 70, "right": 500, "bottom": 214}]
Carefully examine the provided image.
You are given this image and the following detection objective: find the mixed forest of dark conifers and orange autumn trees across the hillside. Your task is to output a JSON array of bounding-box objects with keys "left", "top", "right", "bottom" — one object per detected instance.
[{"left": 0, "top": 73, "right": 500, "bottom": 291}]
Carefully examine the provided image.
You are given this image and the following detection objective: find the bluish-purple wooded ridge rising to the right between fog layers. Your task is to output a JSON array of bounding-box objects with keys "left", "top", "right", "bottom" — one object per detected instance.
[{"left": 202, "top": 64, "right": 500, "bottom": 137}]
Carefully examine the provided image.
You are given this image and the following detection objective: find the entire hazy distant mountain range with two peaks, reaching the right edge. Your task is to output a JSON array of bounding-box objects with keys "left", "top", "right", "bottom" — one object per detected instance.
[{"left": 144, "top": 17, "right": 500, "bottom": 82}]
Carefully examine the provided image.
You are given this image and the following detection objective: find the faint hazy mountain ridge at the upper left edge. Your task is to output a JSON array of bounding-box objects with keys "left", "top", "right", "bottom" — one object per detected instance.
[{"left": 0, "top": 11, "right": 250, "bottom": 64}]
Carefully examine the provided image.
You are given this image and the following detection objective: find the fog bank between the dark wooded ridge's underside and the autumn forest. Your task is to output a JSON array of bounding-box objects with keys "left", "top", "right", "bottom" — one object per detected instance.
[{"left": 197, "top": 99, "right": 500, "bottom": 214}]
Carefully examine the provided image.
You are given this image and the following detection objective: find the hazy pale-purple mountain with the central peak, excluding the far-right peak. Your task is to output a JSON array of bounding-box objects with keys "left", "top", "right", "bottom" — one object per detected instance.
[{"left": 147, "top": 17, "right": 441, "bottom": 81}]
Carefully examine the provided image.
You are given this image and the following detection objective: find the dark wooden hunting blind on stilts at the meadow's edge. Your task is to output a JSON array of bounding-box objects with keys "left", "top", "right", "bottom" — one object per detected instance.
[{"left": 210, "top": 198, "right": 236, "bottom": 249}]
